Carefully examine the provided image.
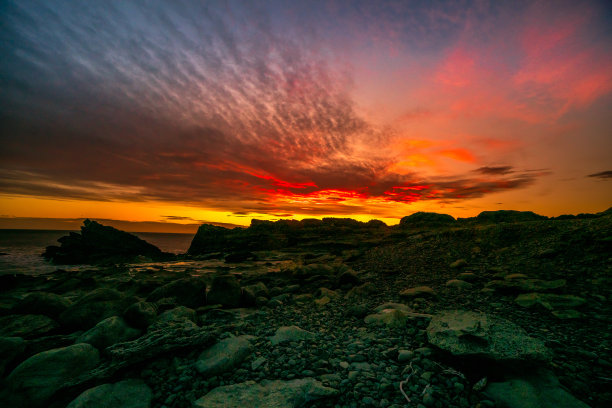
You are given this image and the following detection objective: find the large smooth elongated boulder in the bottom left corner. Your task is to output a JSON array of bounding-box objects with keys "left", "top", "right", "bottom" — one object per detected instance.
[{"left": 5, "top": 343, "right": 100, "bottom": 407}]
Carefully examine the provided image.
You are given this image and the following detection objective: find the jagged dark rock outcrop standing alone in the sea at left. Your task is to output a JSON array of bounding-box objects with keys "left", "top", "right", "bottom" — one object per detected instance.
[{"left": 43, "top": 220, "right": 174, "bottom": 265}]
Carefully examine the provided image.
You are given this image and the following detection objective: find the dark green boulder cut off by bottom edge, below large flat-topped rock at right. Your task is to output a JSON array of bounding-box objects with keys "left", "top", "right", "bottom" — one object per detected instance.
[{"left": 485, "top": 372, "right": 588, "bottom": 408}]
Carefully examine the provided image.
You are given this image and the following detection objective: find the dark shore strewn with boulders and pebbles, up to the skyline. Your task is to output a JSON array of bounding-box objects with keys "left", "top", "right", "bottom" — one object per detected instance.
[{"left": 0, "top": 211, "right": 612, "bottom": 408}]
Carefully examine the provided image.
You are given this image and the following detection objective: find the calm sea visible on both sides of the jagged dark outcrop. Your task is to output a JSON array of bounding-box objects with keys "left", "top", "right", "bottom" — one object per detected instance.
[{"left": 0, "top": 229, "right": 193, "bottom": 275}]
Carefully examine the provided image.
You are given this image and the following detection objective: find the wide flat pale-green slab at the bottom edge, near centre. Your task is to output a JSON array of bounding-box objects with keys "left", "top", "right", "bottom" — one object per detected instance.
[{"left": 193, "top": 378, "right": 338, "bottom": 408}]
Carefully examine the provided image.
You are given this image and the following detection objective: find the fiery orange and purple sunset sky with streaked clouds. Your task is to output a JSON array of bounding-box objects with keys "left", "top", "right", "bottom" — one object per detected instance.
[{"left": 0, "top": 0, "right": 612, "bottom": 230}]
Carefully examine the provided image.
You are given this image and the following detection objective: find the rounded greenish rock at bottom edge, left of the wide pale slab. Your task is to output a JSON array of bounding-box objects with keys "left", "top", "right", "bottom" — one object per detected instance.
[{"left": 66, "top": 379, "right": 153, "bottom": 408}]
